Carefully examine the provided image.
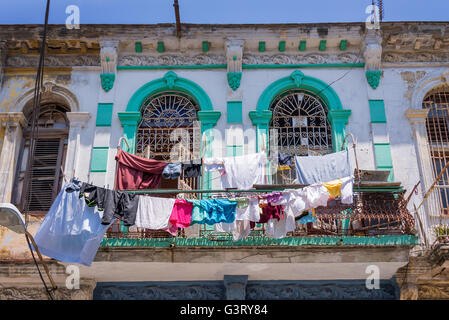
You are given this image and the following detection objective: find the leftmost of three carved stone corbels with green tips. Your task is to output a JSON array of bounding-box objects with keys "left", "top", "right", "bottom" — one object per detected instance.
[{"left": 100, "top": 40, "right": 119, "bottom": 92}]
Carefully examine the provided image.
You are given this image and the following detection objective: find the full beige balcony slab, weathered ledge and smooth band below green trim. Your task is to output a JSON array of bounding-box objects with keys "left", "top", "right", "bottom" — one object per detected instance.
[{"left": 65, "top": 245, "right": 410, "bottom": 282}]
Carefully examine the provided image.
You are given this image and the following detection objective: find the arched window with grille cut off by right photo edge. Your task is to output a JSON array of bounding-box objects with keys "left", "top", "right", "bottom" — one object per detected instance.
[{"left": 423, "top": 85, "right": 449, "bottom": 214}]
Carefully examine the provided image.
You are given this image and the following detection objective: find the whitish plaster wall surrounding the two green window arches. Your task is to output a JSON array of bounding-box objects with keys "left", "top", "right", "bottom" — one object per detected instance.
[{"left": 62, "top": 68, "right": 440, "bottom": 205}]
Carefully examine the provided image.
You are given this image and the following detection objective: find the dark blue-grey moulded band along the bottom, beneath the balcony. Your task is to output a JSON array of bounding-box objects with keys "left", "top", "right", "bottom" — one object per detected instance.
[{"left": 94, "top": 276, "right": 399, "bottom": 300}]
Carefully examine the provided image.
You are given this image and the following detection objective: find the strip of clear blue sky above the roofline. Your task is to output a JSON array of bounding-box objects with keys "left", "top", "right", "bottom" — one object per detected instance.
[{"left": 0, "top": 0, "right": 449, "bottom": 24}]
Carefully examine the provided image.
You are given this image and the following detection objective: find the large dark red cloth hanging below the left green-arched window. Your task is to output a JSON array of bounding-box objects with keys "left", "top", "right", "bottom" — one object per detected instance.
[{"left": 115, "top": 149, "right": 167, "bottom": 190}]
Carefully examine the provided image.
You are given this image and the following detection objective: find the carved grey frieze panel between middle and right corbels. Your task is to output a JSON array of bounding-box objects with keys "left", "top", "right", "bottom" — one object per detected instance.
[{"left": 243, "top": 53, "right": 362, "bottom": 65}]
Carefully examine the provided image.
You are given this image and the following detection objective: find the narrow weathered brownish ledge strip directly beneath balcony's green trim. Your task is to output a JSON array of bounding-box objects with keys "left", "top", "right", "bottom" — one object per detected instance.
[{"left": 95, "top": 246, "right": 411, "bottom": 263}]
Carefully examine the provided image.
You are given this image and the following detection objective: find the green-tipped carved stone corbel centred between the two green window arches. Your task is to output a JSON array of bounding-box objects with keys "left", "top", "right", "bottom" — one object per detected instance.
[{"left": 226, "top": 39, "right": 244, "bottom": 91}]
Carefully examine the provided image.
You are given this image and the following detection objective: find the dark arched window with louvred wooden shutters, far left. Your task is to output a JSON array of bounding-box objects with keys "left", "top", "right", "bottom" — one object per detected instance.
[{"left": 13, "top": 103, "right": 70, "bottom": 215}]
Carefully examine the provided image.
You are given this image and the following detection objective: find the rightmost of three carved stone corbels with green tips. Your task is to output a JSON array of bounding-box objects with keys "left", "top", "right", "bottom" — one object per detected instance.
[{"left": 363, "top": 29, "right": 382, "bottom": 89}]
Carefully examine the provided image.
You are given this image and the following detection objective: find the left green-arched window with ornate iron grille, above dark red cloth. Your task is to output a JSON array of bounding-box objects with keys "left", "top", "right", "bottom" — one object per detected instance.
[{"left": 136, "top": 91, "right": 201, "bottom": 189}]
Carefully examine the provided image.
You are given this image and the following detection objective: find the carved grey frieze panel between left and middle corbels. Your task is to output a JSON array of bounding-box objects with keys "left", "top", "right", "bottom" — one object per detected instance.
[{"left": 118, "top": 54, "right": 226, "bottom": 66}]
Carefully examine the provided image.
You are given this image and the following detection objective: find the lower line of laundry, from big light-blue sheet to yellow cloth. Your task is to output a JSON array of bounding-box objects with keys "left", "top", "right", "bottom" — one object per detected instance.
[{"left": 30, "top": 165, "right": 354, "bottom": 266}]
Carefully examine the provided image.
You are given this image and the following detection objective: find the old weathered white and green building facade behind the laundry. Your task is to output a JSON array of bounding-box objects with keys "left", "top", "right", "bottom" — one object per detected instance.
[{"left": 0, "top": 22, "right": 449, "bottom": 299}]
